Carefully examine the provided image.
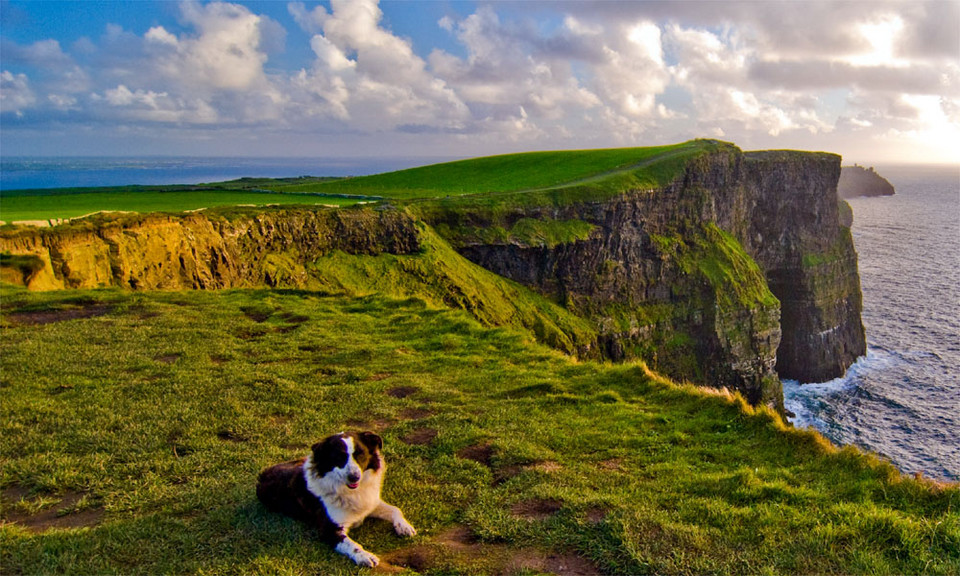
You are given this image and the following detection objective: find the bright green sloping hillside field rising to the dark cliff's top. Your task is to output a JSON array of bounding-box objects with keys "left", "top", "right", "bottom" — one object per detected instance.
[{"left": 278, "top": 140, "right": 718, "bottom": 200}]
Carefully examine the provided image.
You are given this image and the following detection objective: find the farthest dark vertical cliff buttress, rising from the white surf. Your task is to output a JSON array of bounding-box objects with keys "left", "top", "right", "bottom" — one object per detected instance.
[{"left": 743, "top": 152, "right": 866, "bottom": 382}]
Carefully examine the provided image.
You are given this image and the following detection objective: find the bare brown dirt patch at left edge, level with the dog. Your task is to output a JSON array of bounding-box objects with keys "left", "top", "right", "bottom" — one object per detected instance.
[{"left": 0, "top": 486, "right": 104, "bottom": 532}]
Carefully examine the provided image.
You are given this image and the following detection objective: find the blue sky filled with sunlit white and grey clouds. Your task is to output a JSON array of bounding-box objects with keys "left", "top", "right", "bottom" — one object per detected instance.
[{"left": 0, "top": 0, "right": 960, "bottom": 163}]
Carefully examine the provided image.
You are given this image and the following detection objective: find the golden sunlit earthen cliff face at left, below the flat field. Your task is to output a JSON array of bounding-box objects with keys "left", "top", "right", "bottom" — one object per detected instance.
[{"left": 0, "top": 210, "right": 420, "bottom": 290}]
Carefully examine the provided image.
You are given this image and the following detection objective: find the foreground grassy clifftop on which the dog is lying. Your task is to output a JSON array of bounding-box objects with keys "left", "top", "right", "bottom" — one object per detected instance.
[{"left": 0, "top": 287, "right": 960, "bottom": 574}]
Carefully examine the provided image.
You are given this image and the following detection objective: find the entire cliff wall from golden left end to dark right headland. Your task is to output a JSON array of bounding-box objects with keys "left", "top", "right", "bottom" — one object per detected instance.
[{"left": 0, "top": 142, "right": 865, "bottom": 408}]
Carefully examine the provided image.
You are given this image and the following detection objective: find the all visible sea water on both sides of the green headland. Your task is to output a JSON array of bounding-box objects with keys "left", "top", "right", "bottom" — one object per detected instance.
[{"left": 0, "top": 158, "right": 960, "bottom": 481}]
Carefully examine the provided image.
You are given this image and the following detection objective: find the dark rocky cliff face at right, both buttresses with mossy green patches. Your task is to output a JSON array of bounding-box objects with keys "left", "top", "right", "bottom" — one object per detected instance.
[{"left": 431, "top": 147, "right": 865, "bottom": 398}]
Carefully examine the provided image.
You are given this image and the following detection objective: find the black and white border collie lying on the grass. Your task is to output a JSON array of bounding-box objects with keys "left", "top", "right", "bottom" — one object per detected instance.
[{"left": 257, "top": 432, "right": 417, "bottom": 566}]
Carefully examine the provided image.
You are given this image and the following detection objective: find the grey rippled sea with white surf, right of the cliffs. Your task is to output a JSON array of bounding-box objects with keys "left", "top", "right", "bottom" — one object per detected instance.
[{"left": 784, "top": 167, "right": 960, "bottom": 481}]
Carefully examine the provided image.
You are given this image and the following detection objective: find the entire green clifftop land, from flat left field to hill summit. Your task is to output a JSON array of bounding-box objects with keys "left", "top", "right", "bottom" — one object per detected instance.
[{"left": 0, "top": 140, "right": 729, "bottom": 223}]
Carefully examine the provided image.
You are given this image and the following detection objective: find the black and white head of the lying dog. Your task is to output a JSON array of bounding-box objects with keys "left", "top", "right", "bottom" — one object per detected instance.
[{"left": 312, "top": 432, "right": 383, "bottom": 490}]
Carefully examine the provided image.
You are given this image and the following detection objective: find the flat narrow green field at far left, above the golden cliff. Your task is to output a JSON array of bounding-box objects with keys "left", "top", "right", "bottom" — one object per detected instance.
[{"left": 0, "top": 190, "right": 358, "bottom": 222}]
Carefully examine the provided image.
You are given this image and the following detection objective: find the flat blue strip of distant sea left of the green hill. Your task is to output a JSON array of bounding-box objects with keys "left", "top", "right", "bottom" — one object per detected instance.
[{"left": 0, "top": 157, "right": 452, "bottom": 191}]
